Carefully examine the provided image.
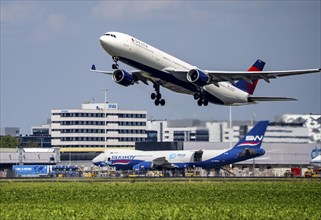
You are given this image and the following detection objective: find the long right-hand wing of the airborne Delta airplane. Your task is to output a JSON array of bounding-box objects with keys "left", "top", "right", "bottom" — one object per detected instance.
[{"left": 163, "top": 68, "right": 321, "bottom": 85}]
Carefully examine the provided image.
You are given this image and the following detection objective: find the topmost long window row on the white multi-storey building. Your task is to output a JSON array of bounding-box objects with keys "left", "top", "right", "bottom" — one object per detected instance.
[{"left": 52, "top": 112, "right": 146, "bottom": 118}]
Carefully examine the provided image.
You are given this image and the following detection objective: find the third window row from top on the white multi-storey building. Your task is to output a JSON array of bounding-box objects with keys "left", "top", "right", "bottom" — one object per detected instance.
[{"left": 52, "top": 129, "right": 146, "bottom": 134}]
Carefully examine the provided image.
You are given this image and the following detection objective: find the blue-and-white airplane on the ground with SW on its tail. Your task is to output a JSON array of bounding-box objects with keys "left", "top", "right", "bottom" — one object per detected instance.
[{"left": 92, "top": 121, "right": 269, "bottom": 171}]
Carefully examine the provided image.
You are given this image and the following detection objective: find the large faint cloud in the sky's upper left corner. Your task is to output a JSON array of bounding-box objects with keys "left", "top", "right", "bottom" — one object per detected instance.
[{"left": 1, "top": 2, "right": 80, "bottom": 41}]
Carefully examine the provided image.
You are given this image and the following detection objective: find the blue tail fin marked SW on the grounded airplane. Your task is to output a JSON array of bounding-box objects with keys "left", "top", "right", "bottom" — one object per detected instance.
[{"left": 234, "top": 121, "right": 269, "bottom": 148}]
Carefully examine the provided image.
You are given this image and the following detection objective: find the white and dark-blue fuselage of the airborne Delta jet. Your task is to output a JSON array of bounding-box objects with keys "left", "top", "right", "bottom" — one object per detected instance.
[{"left": 100, "top": 32, "right": 251, "bottom": 105}]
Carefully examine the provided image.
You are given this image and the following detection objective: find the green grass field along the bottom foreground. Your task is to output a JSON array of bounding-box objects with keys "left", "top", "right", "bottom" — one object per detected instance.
[{"left": 0, "top": 180, "right": 321, "bottom": 220}]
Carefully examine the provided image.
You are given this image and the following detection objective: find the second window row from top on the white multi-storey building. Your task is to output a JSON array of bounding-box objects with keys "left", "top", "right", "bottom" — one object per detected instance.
[{"left": 52, "top": 121, "right": 146, "bottom": 126}]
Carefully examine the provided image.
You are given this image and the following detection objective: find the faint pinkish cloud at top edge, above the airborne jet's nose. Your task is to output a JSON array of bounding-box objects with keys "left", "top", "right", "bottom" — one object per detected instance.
[{"left": 91, "top": 1, "right": 180, "bottom": 21}]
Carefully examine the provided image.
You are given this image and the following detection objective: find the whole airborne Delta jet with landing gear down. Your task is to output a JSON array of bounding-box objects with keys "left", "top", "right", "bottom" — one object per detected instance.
[{"left": 91, "top": 32, "right": 320, "bottom": 106}]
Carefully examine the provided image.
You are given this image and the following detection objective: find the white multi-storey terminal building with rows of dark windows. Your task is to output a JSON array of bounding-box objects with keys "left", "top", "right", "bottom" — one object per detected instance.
[{"left": 51, "top": 103, "right": 147, "bottom": 148}]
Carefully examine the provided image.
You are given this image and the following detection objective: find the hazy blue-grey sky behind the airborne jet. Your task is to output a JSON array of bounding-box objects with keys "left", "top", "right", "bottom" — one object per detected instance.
[{"left": 0, "top": 0, "right": 321, "bottom": 134}]
